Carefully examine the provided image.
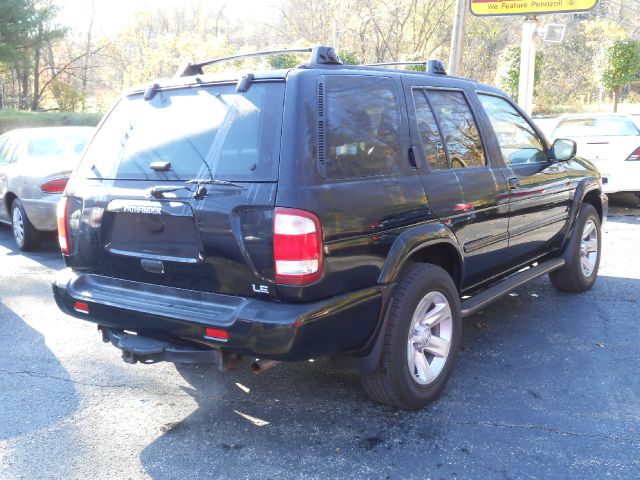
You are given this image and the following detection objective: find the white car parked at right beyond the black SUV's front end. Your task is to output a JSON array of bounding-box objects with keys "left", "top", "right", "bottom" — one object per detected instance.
[{"left": 550, "top": 114, "right": 640, "bottom": 193}]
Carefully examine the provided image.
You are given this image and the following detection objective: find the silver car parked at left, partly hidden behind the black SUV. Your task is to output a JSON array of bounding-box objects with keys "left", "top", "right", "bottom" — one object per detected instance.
[{"left": 0, "top": 127, "right": 95, "bottom": 251}]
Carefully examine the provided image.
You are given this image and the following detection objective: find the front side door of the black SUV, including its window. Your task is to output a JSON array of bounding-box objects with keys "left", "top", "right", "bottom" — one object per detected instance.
[{"left": 478, "top": 92, "right": 575, "bottom": 265}]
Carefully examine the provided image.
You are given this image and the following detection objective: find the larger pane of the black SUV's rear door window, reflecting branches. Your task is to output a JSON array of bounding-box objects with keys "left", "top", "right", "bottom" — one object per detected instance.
[{"left": 427, "top": 90, "right": 486, "bottom": 168}]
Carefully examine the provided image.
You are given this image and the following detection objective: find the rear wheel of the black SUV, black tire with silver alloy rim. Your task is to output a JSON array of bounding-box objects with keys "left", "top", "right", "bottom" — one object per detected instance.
[{"left": 361, "top": 264, "right": 462, "bottom": 410}]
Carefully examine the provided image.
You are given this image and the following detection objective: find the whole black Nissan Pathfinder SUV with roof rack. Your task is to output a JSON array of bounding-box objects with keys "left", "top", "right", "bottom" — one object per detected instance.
[{"left": 53, "top": 47, "right": 607, "bottom": 408}]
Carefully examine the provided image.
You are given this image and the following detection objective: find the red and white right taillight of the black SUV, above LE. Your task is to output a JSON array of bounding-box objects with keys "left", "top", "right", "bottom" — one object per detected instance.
[{"left": 273, "top": 207, "right": 323, "bottom": 285}]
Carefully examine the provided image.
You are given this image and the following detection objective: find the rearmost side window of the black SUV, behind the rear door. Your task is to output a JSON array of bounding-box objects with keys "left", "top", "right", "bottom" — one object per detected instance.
[{"left": 321, "top": 75, "right": 401, "bottom": 178}]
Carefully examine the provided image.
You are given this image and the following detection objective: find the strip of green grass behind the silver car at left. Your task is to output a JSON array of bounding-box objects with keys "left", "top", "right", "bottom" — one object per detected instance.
[{"left": 0, "top": 110, "right": 102, "bottom": 134}]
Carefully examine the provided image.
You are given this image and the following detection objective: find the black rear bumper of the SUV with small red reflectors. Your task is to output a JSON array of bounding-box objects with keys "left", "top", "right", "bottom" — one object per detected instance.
[{"left": 53, "top": 269, "right": 383, "bottom": 360}]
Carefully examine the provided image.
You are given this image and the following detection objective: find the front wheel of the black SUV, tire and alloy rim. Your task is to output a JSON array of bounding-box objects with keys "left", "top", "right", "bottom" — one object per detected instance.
[{"left": 549, "top": 203, "right": 602, "bottom": 293}]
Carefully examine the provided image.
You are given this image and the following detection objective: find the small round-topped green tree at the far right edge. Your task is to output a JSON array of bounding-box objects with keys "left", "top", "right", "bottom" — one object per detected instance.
[{"left": 600, "top": 40, "right": 640, "bottom": 112}]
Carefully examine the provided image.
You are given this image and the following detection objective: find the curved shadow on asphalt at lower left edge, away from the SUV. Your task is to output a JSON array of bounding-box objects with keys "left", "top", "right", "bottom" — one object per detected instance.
[{"left": 0, "top": 302, "right": 78, "bottom": 442}]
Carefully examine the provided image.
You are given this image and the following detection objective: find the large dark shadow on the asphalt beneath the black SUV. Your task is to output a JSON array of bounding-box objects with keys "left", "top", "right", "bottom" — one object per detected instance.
[{"left": 140, "top": 277, "right": 640, "bottom": 478}]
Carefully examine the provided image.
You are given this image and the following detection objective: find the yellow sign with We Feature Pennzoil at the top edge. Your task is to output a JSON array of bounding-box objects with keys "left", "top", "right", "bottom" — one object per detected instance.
[{"left": 471, "top": 0, "right": 598, "bottom": 16}]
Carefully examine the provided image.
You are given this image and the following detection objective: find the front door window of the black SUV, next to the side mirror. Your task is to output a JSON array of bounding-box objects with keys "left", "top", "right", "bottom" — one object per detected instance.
[{"left": 478, "top": 94, "right": 547, "bottom": 165}]
